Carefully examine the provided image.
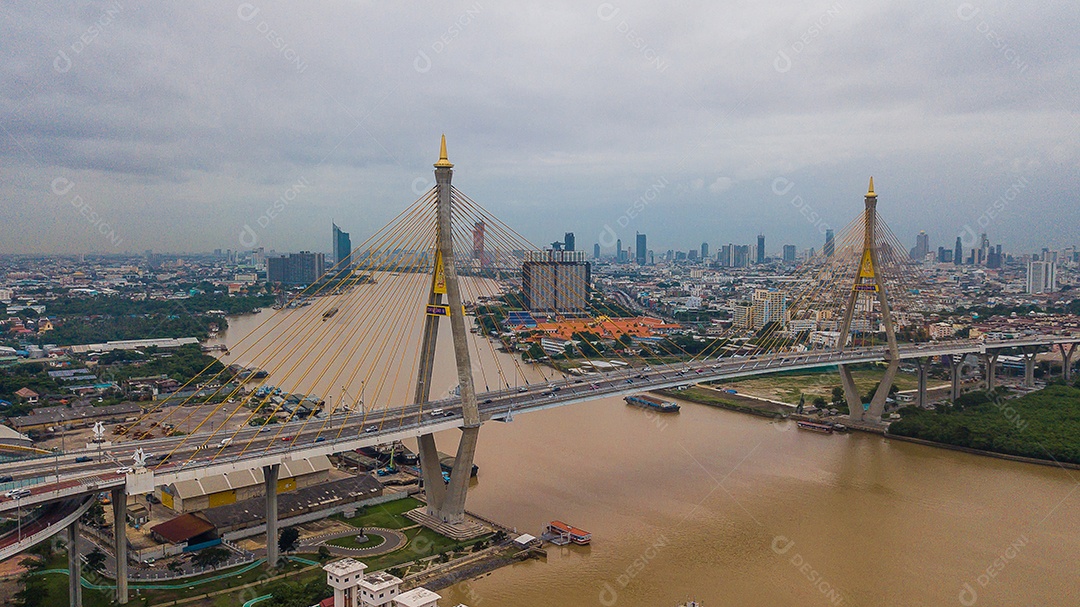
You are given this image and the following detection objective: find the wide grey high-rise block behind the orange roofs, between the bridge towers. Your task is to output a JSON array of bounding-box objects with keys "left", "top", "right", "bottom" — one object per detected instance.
[{"left": 522, "top": 251, "right": 592, "bottom": 313}]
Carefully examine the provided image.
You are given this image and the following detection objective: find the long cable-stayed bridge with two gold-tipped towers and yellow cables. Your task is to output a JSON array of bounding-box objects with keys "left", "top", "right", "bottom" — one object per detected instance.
[{"left": 0, "top": 139, "right": 1080, "bottom": 603}]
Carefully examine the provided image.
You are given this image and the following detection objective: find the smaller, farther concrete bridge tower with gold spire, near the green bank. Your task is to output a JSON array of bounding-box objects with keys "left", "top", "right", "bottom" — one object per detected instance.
[{"left": 838, "top": 177, "right": 900, "bottom": 421}]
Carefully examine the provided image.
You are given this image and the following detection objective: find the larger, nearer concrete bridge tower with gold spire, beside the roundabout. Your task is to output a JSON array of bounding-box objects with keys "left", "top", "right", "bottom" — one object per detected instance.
[{"left": 414, "top": 135, "right": 481, "bottom": 525}]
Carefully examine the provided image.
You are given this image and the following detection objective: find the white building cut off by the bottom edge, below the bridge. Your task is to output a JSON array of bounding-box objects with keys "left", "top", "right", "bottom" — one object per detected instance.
[{"left": 323, "top": 558, "right": 455, "bottom": 607}]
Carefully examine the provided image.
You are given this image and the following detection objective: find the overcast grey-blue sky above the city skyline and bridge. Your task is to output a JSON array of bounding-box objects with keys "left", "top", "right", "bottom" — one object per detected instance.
[{"left": 0, "top": 0, "right": 1080, "bottom": 253}]
